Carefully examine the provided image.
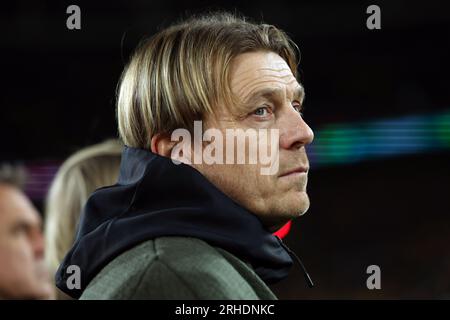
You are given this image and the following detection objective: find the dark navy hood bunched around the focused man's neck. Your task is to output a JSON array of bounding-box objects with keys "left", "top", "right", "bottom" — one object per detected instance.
[{"left": 55, "top": 147, "right": 306, "bottom": 298}]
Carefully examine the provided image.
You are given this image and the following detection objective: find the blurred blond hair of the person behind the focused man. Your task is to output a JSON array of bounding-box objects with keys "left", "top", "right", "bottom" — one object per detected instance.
[{"left": 45, "top": 140, "right": 123, "bottom": 299}]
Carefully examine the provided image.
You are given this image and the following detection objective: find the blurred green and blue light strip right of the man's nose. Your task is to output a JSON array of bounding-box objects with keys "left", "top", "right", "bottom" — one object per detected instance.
[{"left": 307, "top": 111, "right": 450, "bottom": 169}]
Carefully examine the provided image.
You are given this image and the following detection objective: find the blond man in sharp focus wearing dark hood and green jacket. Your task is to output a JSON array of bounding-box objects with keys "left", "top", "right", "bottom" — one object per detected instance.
[{"left": 56, "top": 13, "right": 313, "bottom": 299}]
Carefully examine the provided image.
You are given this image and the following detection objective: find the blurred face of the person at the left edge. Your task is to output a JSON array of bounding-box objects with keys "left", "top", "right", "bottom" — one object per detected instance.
[{"left": 0, "top": 184, "right": 53, "bottom": 299}]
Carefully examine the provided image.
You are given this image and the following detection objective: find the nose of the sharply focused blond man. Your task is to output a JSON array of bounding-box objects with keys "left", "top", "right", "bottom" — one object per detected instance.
[{"left": 280, "top": 106, "right": 314, "bottom": 149}]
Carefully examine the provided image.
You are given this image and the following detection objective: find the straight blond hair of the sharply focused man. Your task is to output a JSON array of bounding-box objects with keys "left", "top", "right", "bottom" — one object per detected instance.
[{"left": 117, "top": 13, "right": 299, "bottom": 150}]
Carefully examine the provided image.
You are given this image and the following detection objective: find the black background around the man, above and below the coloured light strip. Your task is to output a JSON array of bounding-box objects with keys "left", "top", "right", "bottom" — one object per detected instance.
[{"left": 0, "top": 0, "right": 450, "bottom": 299}]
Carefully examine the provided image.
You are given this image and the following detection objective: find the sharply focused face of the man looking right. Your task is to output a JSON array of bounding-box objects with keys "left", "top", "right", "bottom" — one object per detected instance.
[{"left": 193, "top": 51, "right": 314, "bottom": 230}]
